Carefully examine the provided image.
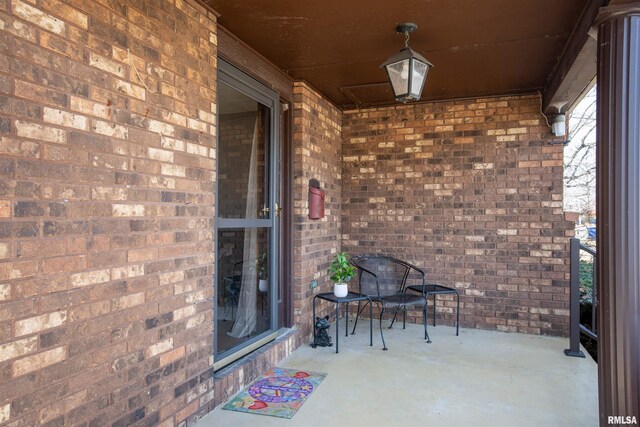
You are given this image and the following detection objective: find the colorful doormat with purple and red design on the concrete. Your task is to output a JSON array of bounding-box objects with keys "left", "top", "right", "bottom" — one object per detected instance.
[{"left": 222, "top": 368, "right": 327, "bottom": 418}]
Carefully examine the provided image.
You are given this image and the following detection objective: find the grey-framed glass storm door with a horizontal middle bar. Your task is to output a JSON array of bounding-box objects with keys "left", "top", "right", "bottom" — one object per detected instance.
[{"left": 214, "top": 60, "right": 279, "bottom": 362}]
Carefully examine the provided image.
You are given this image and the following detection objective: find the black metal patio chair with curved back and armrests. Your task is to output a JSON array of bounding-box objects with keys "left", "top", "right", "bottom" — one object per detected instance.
[{"left": 350, "top": 255, "right": 431, "bottom": 350}]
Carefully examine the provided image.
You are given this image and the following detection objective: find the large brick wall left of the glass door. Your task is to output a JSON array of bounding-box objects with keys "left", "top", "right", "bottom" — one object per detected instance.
[{"left": 0, "top": 0, "right": 216, "bottom": 426}]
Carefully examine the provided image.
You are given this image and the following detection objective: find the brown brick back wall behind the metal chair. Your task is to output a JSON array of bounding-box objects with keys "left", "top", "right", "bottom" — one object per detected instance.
[{"left": 342, "top": 96, "right": 573, "bottom": 335}]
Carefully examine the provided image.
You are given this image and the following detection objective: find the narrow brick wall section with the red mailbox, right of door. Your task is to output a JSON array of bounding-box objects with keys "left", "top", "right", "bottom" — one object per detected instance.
[{"left": 293, "top": 82, "right": 342, "bottom": 335}]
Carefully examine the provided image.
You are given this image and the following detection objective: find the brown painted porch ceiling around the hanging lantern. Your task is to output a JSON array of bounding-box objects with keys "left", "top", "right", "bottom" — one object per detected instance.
[{"left": 203, "top": 0, "right": 588, "bottom": 106}]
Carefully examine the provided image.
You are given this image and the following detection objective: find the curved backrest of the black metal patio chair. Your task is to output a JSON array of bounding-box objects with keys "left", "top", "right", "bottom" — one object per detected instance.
[{"left": 350, "top": 254, "right": 424, "bottom": 297}]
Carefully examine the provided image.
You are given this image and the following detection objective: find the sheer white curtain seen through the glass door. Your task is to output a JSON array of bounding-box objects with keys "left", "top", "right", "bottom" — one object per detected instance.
[{"left": 227, "top": 111, "right": 263, "bottom": 338}]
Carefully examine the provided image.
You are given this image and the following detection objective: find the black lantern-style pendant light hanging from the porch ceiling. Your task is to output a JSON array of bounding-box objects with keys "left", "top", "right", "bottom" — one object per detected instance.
[{"left": 380, "top": 23, "right": 433, "bottom": 102}]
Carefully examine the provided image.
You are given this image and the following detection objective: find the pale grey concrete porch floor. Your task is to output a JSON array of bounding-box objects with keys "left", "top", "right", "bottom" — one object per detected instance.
[{"left": 197, "top": 319, "right": 598, "bottom": 427}]
